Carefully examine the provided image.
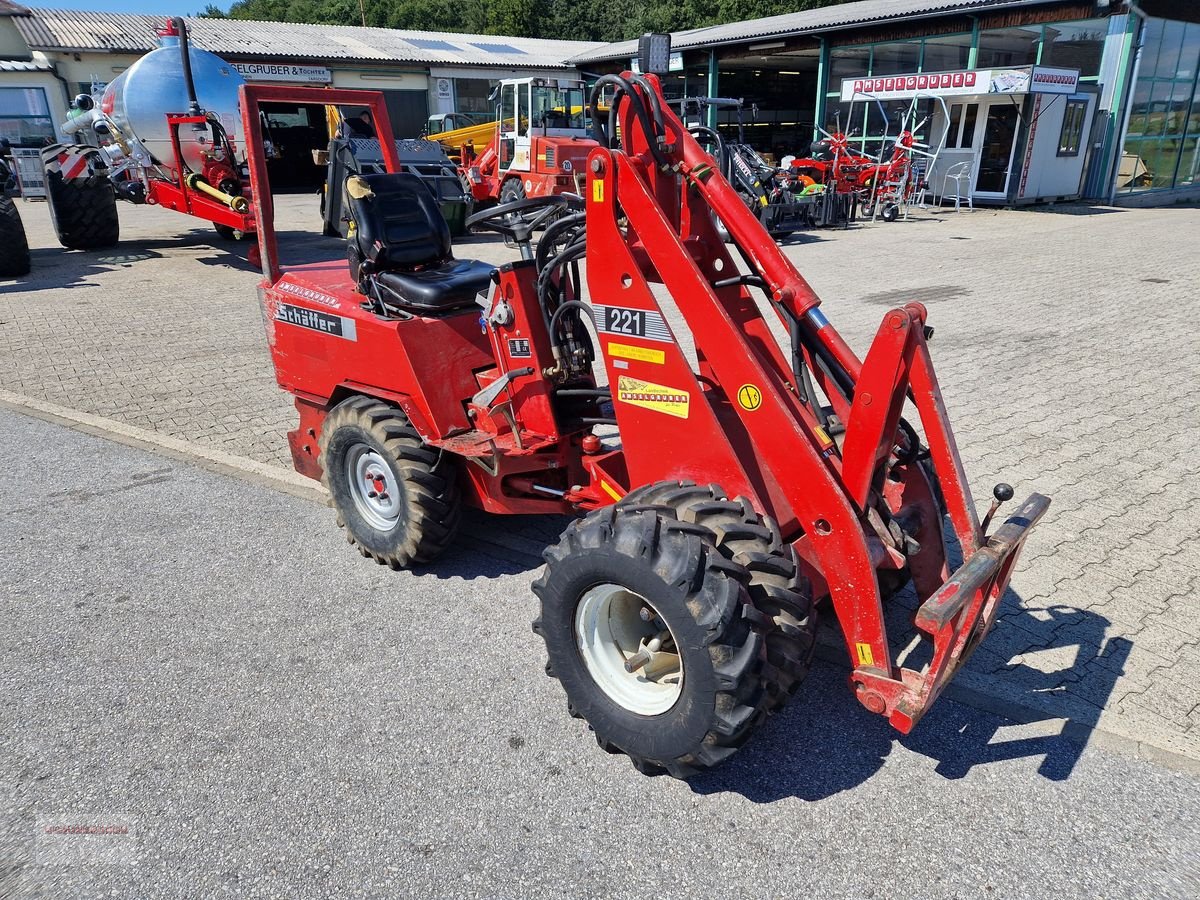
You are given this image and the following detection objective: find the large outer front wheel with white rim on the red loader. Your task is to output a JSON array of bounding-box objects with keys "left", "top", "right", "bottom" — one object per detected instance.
[{"left": 533, "top": 506, "right": 762, "bottom": 778}]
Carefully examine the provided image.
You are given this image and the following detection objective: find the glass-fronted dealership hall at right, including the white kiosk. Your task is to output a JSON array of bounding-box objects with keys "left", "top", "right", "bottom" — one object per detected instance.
[{"left": 571, "top": 0, "right": 1200, "bottom": 205}]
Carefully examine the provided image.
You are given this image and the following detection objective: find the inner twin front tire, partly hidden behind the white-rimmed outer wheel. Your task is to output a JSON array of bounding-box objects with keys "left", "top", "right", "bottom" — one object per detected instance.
[{"left": 622, "top": 481, "right": 817, "bottom": 713}]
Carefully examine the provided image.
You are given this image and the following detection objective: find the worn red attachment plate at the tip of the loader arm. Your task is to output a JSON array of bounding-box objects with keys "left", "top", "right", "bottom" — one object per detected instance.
[{"left": 851, "top": 493, "right": 1050, "bottom": 734}]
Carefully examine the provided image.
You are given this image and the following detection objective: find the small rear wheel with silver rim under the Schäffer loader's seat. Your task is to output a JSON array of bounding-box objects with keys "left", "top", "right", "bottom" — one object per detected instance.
[{"left": 320, "top": 397, "right": 462, "bottom": 569}]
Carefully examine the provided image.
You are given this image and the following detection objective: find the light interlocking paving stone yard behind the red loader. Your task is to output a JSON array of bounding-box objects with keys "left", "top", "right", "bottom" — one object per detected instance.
[{"left": 0, "top": 197, "right": 1200, "bottom": 758}]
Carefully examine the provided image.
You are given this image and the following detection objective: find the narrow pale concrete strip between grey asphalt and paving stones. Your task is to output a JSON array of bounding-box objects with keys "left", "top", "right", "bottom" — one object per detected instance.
[{"left": 0, "top": 389, "right": 1200, "bottom": 776}]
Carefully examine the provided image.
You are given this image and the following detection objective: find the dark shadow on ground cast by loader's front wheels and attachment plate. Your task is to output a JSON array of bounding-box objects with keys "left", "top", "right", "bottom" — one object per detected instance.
[{"left": 690, "top": 590, "right": 1132, "bottom": 803}]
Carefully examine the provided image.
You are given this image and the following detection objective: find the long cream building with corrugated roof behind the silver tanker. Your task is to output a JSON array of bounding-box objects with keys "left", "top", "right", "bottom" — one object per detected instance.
[{"left": 0, "top": 0, "right": 599, "bottom": 146}]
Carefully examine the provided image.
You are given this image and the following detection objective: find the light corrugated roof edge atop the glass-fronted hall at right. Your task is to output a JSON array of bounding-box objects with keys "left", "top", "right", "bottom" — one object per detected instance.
[{"left": 570, "top": 0, "right": 1064, "bottom": 65}]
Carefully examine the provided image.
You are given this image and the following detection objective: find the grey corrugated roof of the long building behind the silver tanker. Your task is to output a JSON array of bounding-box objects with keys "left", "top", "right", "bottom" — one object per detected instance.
[{"left": 13, "top": 8, "right": 604, "bottom": 68}]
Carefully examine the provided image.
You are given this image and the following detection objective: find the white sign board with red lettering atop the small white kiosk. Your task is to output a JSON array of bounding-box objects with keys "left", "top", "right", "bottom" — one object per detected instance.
[{"left": 841, "top": 66, "right": 1079, "bottom": 103}]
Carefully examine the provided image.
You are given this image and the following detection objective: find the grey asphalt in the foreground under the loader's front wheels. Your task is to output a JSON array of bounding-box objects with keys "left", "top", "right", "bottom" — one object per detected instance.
[{"left": 0, "top": 410, "right": 1200, "bottom": 898}]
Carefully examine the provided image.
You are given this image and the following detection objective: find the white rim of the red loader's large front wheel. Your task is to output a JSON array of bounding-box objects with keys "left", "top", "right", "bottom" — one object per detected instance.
[{"left": 575, "top": 584, "right": 683, "bottom": 715}]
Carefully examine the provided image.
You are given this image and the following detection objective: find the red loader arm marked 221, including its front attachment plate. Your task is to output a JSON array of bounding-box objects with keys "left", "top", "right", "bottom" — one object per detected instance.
[{"left": 576, "top": 73, "right": 1049, "bottom": 731}]
